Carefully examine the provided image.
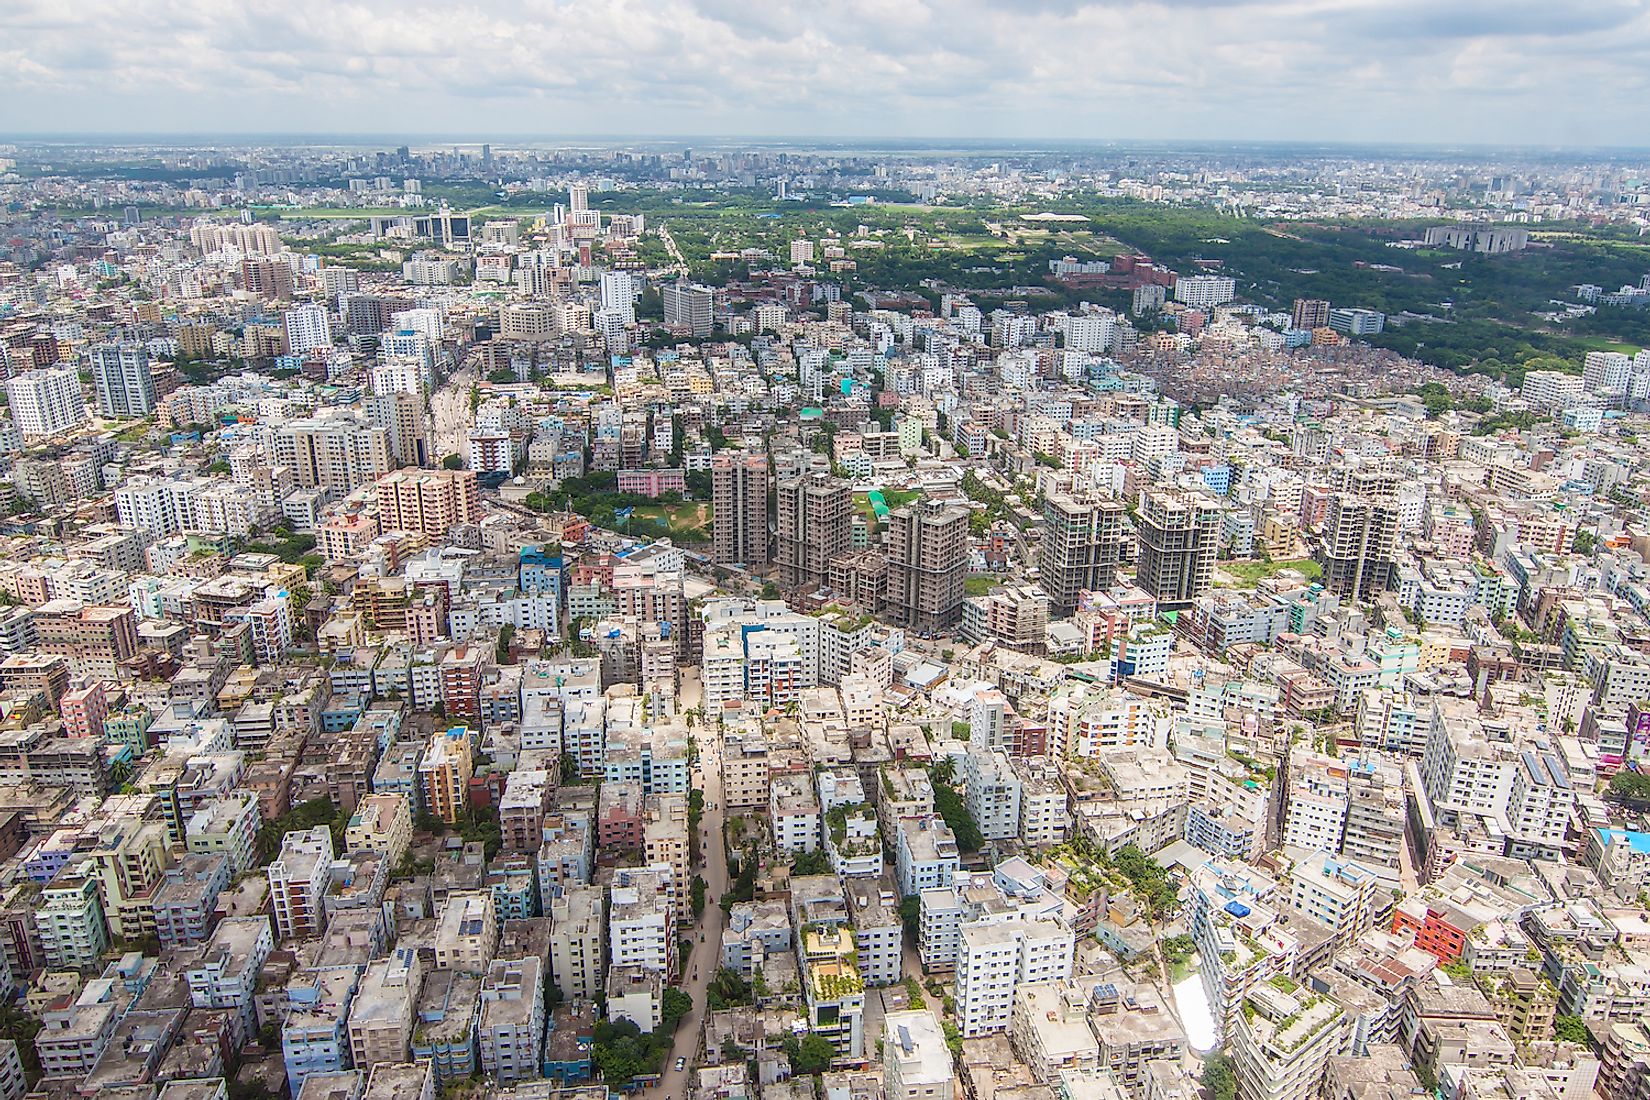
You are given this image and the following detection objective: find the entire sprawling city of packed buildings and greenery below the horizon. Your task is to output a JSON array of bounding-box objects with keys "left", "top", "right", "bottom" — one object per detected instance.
[{"left": 0, "top": 140, "right": 1650, "bottom": 1100}]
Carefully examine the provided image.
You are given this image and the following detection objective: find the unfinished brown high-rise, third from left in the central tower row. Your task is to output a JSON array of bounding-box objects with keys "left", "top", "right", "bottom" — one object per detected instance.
[{"left": 886, "top": 500, "right": 969, "bottom": 630}]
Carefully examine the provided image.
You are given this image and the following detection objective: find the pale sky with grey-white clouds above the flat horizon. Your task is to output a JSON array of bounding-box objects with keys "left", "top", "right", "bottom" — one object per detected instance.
[{"left": 0, "top": 0, "right": 1650, "bottom": 147}]
